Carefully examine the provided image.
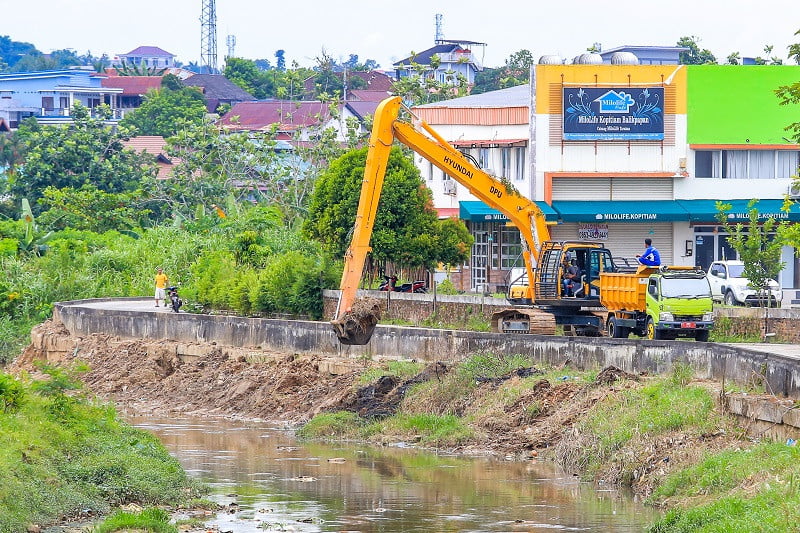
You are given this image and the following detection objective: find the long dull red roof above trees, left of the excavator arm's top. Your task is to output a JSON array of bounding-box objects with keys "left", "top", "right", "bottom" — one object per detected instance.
[{"left": 219, "top": 100, "right": 330, "bottom": 131}]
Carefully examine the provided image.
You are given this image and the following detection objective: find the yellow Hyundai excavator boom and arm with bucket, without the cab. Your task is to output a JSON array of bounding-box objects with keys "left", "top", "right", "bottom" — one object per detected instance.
[{"left": 332, "top": 96, "right": 550, "bottom": 345}]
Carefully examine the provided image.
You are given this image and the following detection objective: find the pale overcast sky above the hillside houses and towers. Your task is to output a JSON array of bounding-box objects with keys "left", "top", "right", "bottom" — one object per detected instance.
[{"left": 6, "top": 0, "right": 800, "bottom": 69}]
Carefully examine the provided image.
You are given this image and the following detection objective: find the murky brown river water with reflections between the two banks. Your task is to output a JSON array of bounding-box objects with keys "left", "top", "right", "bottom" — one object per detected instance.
[{"left": 131, "top": 417, "right": 656, "bottom": 533}]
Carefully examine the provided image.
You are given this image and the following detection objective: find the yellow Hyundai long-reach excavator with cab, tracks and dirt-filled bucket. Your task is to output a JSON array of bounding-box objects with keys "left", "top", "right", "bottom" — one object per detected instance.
[{"left": 331, "top": 96, "right": 616, "bottom": 345}]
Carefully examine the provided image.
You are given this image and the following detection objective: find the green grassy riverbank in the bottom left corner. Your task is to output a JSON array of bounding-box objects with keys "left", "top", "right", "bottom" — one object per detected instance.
[{"left": 0, "top": 365, "right": 206, "bottom": 531}]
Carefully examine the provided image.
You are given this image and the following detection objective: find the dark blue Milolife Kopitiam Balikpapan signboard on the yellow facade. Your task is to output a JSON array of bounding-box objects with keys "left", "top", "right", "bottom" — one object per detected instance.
[{"left": 564, "top": 87, "right": 664, "bottom": 141}]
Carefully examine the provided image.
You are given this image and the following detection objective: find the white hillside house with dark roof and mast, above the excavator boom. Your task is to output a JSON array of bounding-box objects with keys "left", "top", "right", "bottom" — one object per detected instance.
[{"left": 393, "top": 39, "right": 486, "bottom": 85}]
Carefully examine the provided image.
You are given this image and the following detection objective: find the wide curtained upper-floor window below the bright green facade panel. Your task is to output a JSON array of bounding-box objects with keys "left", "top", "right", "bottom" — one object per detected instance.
[{"left": 694, "top": 150, "right": 800, "bottom": 179}]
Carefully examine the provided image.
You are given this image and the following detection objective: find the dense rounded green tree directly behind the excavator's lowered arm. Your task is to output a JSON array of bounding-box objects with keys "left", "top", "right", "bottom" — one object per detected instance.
[{"left": 303, "top": 148, "right": 469, "bottom": 268}]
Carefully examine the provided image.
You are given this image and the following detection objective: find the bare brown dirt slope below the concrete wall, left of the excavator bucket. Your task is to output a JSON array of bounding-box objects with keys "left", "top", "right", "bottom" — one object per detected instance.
[{"left": 9, "top": 321, "right": 357, "bottom": 423}]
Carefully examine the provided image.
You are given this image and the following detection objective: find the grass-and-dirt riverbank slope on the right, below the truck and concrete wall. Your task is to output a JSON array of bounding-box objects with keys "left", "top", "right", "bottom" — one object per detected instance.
[{"left": 299, "top": 354, "right": 800, "bottom": 533}]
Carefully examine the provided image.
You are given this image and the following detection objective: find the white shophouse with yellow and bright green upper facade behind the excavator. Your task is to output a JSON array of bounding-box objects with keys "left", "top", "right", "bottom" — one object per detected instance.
[{"left": 416, "top": 64, "right": 800, "bottom": 296}]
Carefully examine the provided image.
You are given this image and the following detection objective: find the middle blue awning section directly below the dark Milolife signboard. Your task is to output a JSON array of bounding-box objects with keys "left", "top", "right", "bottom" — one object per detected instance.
[{"left": 553, "top": 200, "right": 689, "bottom": 222}]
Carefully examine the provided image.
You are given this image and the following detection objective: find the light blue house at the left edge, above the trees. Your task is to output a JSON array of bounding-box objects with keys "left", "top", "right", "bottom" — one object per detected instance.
[{"left": 0, "top": 69, "right": 122, "bottom": 129}]
